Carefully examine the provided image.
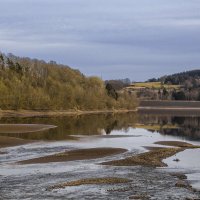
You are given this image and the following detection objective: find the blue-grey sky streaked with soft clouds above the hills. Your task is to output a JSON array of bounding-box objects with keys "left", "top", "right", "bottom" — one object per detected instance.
[{"left": 0, "top": 0, "right": 200, "bottom": 81}]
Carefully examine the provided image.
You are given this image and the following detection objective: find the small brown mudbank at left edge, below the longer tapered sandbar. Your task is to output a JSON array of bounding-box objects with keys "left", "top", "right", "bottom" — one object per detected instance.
[{"left": 0, "top": 136, "right": 34, "bottom": 149}]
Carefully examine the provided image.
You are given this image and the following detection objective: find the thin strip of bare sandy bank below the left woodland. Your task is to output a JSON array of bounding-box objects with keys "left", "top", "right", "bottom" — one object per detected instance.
[{"left": 0, "top": 109, "right": 137, "bottom": 117}]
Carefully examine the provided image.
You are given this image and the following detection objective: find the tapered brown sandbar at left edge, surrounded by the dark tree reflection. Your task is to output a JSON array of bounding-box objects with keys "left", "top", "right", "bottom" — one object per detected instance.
[{"left": 0, "top": 124, "right": 56, "bottom": 133}]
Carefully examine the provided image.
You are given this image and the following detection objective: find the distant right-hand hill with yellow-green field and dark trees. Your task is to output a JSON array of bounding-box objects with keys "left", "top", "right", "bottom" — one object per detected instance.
[{"left": 123, "top": 70, "right": 200, "bottom": 101}]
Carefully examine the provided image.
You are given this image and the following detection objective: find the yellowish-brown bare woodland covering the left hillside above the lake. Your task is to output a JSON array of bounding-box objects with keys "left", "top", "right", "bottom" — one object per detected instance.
[{"left": 0, "top": 53, "right": 137, "bottom": 110}]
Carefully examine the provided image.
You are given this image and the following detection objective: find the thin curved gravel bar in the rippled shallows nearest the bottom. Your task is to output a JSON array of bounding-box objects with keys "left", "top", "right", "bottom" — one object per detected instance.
[{"left": 49, "top": 177, "right": 131, "bottom": 190}]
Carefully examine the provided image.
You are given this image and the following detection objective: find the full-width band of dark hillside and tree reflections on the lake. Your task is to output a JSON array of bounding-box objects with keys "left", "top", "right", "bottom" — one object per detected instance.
[{"left": 0, "top": 113, "right": 200, "bottom": 140}]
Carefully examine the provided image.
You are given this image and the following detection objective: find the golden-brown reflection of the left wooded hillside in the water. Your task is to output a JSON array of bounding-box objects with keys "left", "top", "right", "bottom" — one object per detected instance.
[{"left": 0, "top": 113, "right": 137, "bottom": 140}]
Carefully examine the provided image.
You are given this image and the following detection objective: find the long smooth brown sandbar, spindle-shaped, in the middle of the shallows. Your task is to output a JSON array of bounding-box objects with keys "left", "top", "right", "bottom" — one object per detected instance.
[{"left": 18, "top": 148, "right": 127, "bottom": 164}]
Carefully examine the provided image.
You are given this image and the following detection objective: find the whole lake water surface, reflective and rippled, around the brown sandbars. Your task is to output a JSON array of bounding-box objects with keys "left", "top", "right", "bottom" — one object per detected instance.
[{"left": 0, "top": 113, "right": 200, "bottom": 199}]
